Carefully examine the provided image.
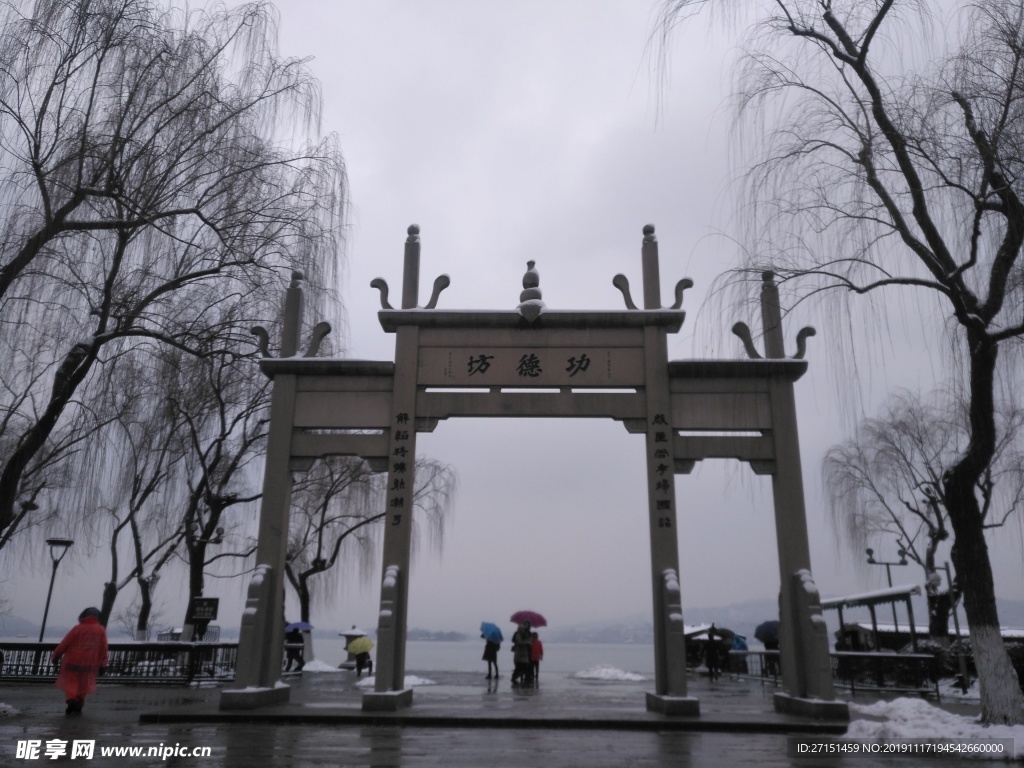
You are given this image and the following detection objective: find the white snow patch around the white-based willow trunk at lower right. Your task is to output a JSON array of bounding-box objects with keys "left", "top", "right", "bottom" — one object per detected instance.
[{"left": 846, "top": 698, "right": 1024, "bottom": 760}]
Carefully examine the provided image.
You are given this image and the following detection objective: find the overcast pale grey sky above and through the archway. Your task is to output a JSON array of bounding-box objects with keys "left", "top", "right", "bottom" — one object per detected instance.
[{"left": 11, "top": 0, "right": 1024, "bottom": 632}]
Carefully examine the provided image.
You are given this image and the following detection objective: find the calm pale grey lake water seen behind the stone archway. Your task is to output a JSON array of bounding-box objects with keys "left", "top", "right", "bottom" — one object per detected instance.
[{"left": 313, "top": 637, "right": 654, "bottom": 678}]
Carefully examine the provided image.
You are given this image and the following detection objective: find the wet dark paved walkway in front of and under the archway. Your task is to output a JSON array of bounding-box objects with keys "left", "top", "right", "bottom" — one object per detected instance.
[{"left": 0, "top": 673, "right": 991, "bottom": 768}]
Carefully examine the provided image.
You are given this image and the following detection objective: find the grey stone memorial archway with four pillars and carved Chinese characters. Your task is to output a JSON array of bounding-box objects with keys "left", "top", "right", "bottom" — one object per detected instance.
[{"left": 220, "top": 225, "right": 848, "bottom": 718}]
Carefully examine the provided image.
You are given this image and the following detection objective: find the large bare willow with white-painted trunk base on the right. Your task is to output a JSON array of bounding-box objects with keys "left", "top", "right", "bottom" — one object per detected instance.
[{"left": 663, "top": 0, "right": 1024, "bottom": 723}]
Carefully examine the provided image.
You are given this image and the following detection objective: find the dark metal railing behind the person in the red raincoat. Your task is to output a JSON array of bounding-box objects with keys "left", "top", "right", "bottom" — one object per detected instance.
[{"left": 0, "top": 642, "right": 239, "bottom": 685}]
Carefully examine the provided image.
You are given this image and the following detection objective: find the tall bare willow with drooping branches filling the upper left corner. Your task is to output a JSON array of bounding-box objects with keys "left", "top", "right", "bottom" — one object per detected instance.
[{"left": 0, "top": 0, "right": 345, "bottom": 545}]
